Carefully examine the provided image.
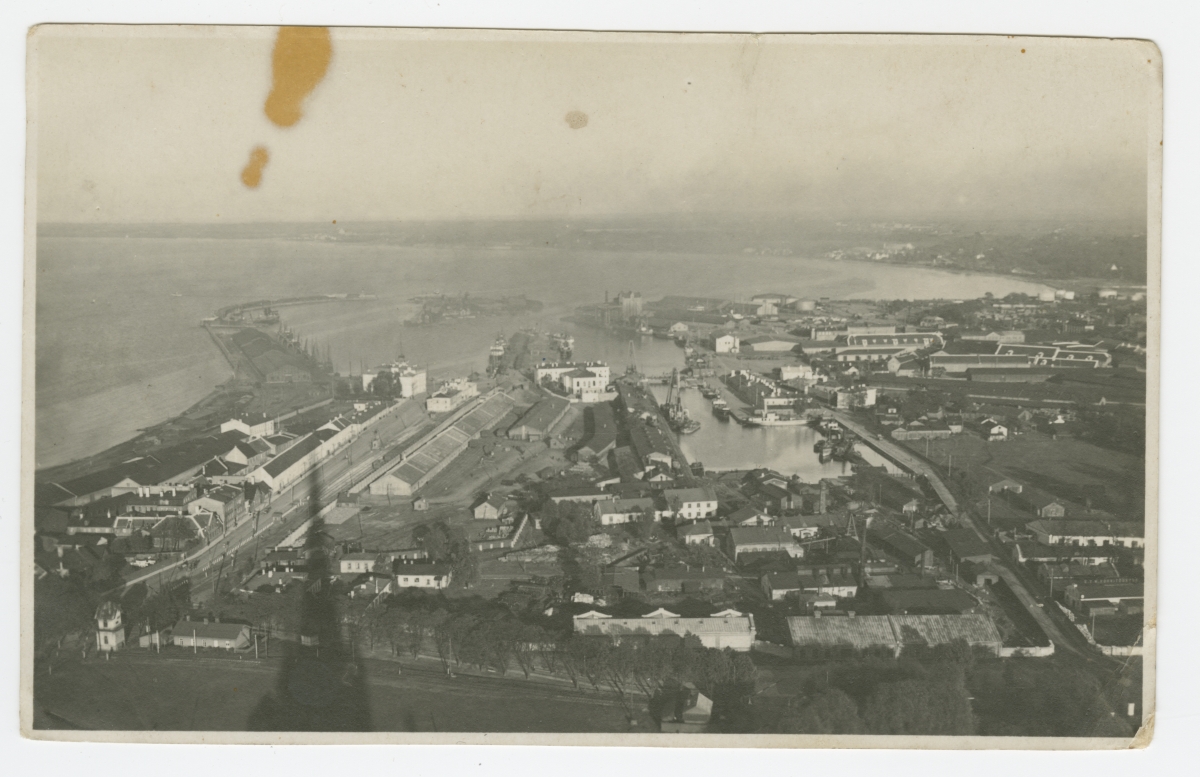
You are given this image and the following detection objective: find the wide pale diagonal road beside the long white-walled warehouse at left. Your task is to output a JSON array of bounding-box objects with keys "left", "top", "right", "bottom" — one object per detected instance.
[{"left": 106, "top": 400, "right": 432, "bottom": 594}]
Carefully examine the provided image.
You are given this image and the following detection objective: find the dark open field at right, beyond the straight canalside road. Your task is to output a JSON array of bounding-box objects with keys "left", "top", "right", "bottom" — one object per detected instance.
[{"left": 904, "top": 433, "right": 1146, "bottom": 520}]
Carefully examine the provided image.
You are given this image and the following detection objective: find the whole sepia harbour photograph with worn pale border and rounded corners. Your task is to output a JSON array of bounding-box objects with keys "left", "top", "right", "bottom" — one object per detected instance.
[{"left": 20, "top": 24, "right": 1163, "bottom": 749}]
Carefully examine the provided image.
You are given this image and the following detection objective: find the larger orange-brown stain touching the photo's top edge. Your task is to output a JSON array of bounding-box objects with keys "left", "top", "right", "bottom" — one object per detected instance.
[{"left": 263, "top": 26, "right": 334, "bottom": 127}]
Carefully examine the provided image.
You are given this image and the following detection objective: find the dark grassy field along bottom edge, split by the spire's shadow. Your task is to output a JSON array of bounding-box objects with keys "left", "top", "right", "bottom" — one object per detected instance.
[{"left": 34, "top": 653, "right": 649, "bottom": 733}]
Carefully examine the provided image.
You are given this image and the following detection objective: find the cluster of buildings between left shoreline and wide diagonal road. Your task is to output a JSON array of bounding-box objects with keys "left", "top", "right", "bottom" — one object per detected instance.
[{"left": 35, "top": 402, "right": 394, "bottom": 577}]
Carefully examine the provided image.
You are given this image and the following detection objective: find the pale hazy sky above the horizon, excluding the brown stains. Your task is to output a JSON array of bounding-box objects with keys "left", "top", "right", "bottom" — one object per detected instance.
[{"left": 31, "top": 28, "right": 1158, "bottom": 222}]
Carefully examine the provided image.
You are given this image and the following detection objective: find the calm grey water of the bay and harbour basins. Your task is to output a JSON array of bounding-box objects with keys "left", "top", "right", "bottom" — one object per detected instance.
[{"left": 36, "top": 237, "right": 1042, "bottom": 474}]
